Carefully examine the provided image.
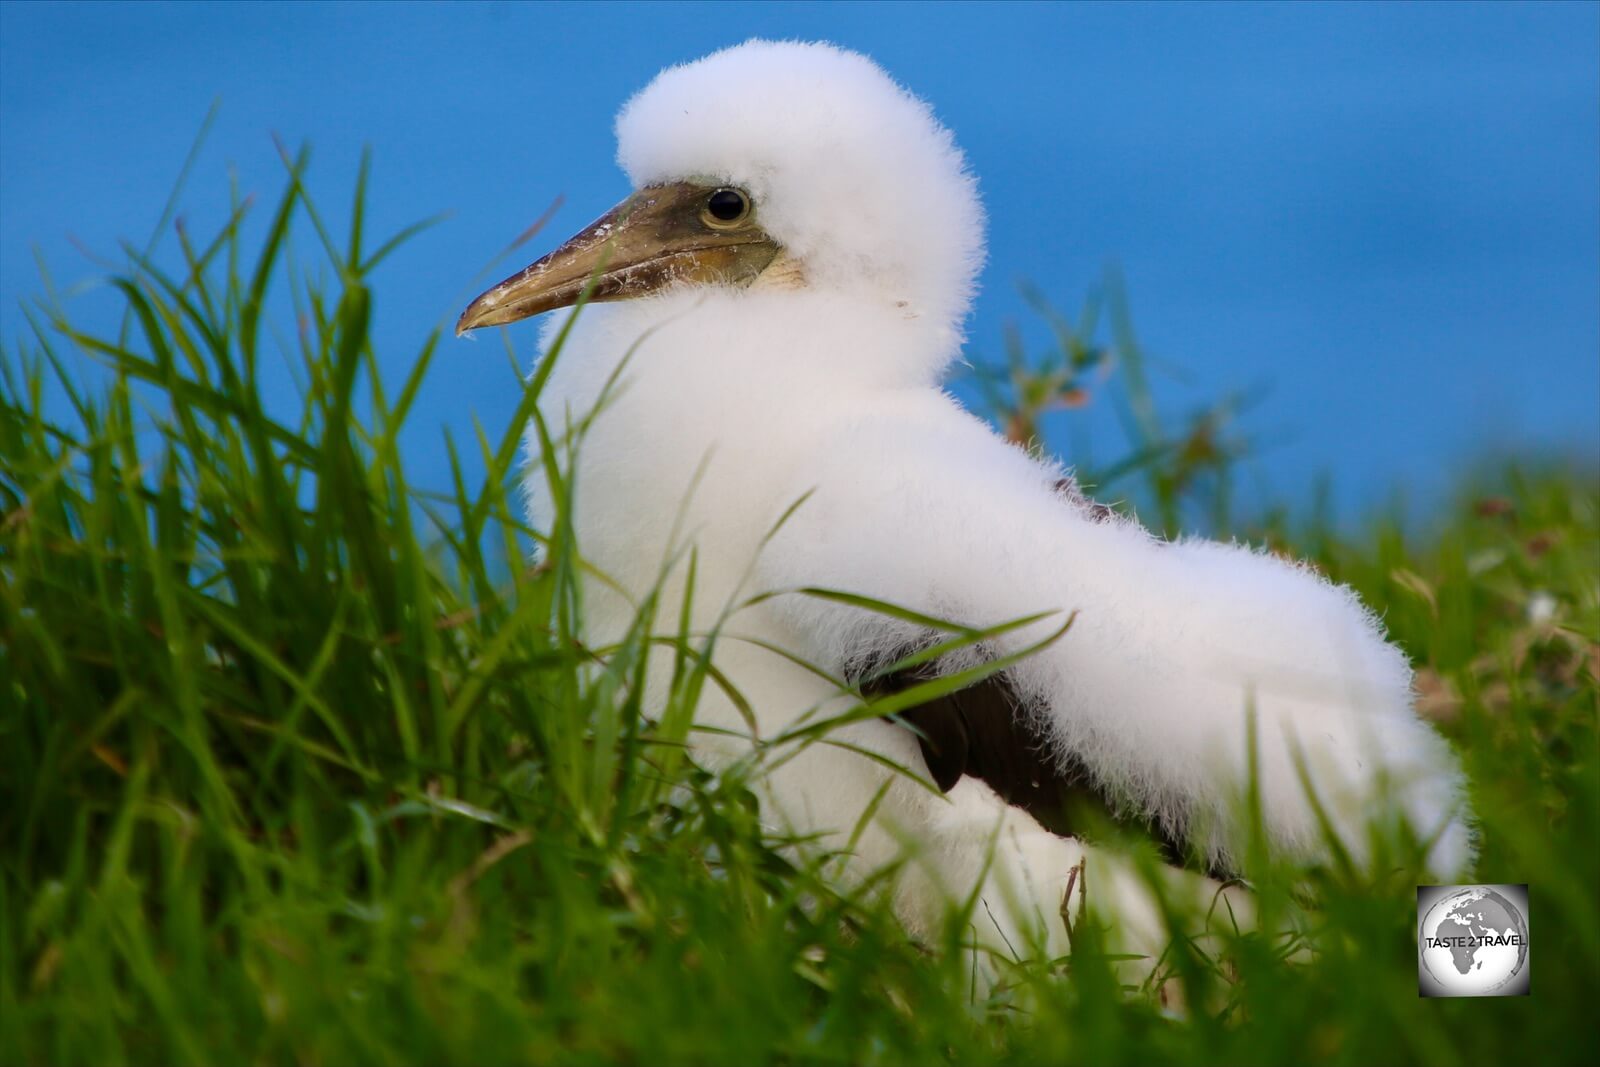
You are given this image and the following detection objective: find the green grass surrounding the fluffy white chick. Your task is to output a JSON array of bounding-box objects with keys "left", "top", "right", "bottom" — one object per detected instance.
[{"left": 0, "top": 157, "right": 1600, "bottom": 1064}]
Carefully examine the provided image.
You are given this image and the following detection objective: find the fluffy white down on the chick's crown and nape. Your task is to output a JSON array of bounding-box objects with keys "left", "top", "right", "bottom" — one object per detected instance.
[{"left": 616, "top": 42, "right": 984, "bottom": 347}]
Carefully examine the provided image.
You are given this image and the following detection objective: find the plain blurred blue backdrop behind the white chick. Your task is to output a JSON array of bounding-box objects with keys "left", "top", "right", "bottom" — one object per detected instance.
[{"left": 0, "top": 3, "right": 1600, "bottom": 515}]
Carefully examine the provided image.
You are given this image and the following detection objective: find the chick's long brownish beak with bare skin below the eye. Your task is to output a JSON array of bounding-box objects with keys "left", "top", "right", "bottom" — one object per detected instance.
[{"left": 456, "top": 182, "right": 779, "bottom": 336}]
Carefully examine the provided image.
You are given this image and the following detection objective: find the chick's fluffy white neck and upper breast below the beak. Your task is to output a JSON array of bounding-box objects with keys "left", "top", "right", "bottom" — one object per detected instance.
[{"left": 530, "top": 283, "right": 954, "bottom": 637}]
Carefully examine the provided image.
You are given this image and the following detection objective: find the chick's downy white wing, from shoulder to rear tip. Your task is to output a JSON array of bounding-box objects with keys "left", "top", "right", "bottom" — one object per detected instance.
[{"left": 758, "top": 402, "right": 1470, "bottom": 872}]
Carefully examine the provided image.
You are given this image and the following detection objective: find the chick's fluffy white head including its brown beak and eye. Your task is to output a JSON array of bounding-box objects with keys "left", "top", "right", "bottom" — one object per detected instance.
[{"left": 456, "top": 40, "right": 982, "bottom": 340}]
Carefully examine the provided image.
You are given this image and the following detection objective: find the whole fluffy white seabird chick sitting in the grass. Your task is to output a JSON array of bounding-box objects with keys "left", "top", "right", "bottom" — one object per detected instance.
[{"left": 458, "top": 40, "right": 1475, "bottom": 979}]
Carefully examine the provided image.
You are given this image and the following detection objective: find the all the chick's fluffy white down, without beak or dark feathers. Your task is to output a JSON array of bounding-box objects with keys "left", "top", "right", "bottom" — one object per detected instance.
[{"left": 505, "top": 42, "right": 1470, "bottom": 979}]
